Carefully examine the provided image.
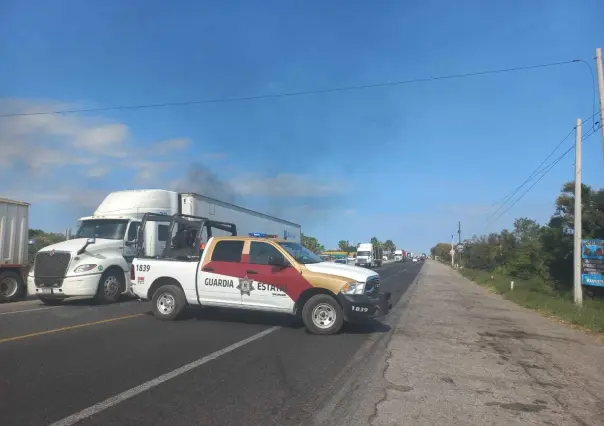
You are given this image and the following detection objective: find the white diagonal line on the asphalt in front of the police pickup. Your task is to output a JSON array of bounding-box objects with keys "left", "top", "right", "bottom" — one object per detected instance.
[{"left": 50, "top": 327, "right": 281, "bottom": 426}]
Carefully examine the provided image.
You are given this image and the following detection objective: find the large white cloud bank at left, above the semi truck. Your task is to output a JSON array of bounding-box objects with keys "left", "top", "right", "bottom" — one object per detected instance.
[{"left": 0, "top": 99, "right": 190, "bottom": 207}]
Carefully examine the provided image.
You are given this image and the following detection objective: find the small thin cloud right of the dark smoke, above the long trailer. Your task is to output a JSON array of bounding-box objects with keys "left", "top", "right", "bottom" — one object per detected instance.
[{"left": 231, "top": 173, "right": 347, "bottom": 197}]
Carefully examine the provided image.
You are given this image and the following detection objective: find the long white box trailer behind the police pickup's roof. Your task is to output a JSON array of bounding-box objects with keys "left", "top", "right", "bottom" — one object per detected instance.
[{"left": 179, "top": 193, "right": 302, "bottom": 243}]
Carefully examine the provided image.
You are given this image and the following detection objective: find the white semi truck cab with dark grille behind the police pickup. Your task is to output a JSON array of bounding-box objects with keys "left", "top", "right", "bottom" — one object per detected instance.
[{"left": 27, "top": 189, "right": 180, "bottom": 304}]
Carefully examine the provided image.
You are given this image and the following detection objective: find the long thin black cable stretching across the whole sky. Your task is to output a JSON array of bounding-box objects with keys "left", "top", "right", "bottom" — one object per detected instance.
[{"left": 0, "top": 59, "right": 582, "bottom": 118}]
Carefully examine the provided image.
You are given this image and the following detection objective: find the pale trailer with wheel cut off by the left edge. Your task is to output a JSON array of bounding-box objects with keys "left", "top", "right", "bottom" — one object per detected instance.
[{"left": 0, "top": 198, "right": 29, "bottom": 301}]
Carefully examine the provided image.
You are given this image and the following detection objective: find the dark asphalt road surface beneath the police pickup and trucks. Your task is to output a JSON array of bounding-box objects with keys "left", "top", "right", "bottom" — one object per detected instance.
[{"left": 0, "top": 262, "right": 421, "bottom": 426}]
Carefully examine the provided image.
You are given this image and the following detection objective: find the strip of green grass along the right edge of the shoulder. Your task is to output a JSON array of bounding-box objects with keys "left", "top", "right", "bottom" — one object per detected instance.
[{"left": 460, "top": 269, "right": 604, "bottom": 335}]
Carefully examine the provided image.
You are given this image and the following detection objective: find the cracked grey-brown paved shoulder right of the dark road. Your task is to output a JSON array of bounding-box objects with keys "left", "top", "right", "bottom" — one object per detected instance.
[{"left": 365, "top": 261, "right": 604, "bottom": 425}]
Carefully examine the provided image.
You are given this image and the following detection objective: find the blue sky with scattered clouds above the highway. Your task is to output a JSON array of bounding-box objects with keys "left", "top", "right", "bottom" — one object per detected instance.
[{"left": 0, "top": 0, "right": 604, "bottom": 251}]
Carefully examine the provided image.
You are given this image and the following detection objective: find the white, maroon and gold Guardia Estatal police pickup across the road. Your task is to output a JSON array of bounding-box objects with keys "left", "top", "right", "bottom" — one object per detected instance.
[{"left": 130, "top": 215, "right": 392, "bottom": 334}]
